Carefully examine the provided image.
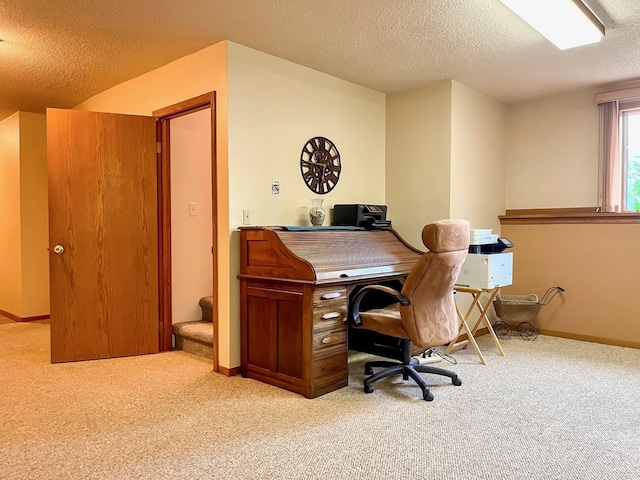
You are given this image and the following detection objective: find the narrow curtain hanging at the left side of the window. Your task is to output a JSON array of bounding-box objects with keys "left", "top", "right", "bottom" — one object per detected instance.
[{"left": 598, "top": 100, "right": 622, "bottom": 212}]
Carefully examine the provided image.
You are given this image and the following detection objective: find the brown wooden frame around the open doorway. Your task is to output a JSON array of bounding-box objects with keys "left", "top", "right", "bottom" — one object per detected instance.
[{"left": 153, "top": 92, "right": 219, "bottom": 372}]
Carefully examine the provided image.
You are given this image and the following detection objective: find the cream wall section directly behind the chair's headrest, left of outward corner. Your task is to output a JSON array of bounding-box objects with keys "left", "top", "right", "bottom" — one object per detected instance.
[{"left": 384, "top": 81, "right": 452, "bottom": 249}]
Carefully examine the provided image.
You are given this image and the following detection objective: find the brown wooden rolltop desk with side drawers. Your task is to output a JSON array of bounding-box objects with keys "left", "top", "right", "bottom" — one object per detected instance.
[{"left": 238, "top": 227, "right": 421, "bottom": 398}]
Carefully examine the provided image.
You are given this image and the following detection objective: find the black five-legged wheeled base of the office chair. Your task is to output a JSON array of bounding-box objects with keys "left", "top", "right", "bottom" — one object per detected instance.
[{"left": 364, "top": 358, "right": 462, "bottom": 402}]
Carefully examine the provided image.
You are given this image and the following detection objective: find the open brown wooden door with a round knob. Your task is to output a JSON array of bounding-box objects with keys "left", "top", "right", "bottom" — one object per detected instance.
[{"left": 47, "top": 109, "right": 160, "bottom": 363}]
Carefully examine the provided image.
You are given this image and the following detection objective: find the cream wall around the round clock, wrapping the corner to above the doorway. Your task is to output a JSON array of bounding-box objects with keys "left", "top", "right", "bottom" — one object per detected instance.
[{"left": 78, "top": 42, "right": 385, "bottom": 368}]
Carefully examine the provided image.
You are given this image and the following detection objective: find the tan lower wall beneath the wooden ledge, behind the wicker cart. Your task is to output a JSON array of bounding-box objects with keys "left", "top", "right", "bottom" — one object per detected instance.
[{"left": 502, "top": 224, "right": 640, "bottom": 348}]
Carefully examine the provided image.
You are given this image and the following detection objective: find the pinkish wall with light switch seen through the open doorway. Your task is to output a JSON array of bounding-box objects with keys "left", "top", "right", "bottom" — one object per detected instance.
[{"left": 170, "top": 108, "right": 213, "bottom": 324}]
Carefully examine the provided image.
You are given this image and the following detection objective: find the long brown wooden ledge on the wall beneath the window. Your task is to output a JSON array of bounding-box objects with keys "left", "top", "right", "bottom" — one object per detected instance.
[{"left": 498, "top": 207, "right": 640, "bottom": 225}]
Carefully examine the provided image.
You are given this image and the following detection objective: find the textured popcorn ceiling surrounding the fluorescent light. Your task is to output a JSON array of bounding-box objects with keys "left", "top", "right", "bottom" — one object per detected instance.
[{"left": 0, "top": 0, "right": 640, "bottom": 118}]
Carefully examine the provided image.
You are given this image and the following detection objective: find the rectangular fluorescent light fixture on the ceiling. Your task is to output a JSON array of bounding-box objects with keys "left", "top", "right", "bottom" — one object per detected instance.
[{"left": 500, "top": 0, "right": 604, "bottom": 50}]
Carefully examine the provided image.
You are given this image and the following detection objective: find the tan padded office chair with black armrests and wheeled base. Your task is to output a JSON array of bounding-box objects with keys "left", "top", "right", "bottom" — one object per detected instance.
[{"left": 350, "top": 219, "right": 469, "bottom": 401}]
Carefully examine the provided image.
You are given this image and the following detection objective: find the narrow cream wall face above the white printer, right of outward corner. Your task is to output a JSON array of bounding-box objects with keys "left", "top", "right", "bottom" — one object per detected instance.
[{"left": 449, "top": 82, "right": 506, "bottom": 233}]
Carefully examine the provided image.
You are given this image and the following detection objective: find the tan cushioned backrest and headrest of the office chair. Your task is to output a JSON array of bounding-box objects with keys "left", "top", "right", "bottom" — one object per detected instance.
[{"left": 400, "top": 219, "right": 469, "bottom": 348}]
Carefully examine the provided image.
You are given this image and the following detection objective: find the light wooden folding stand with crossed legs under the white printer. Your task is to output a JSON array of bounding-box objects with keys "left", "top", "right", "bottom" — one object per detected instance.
[{"left": 444, "top": 285, "right": 504, "bottom": 365}]
